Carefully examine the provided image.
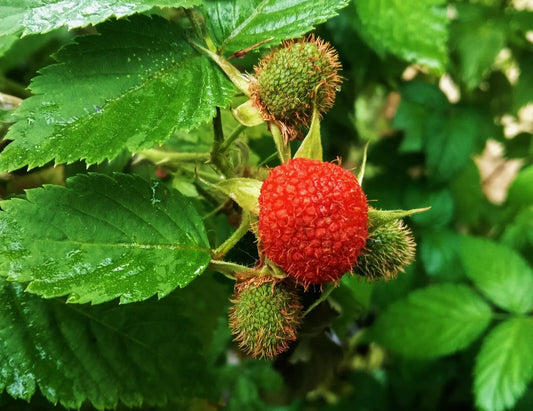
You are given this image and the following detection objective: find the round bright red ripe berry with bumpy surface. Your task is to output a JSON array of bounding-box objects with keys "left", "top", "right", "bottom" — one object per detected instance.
[{"left": 259, "top": 158, "right": 368, "bottom": 285}]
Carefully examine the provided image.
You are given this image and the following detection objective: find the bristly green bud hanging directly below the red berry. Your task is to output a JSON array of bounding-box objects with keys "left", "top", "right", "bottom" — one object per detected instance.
[{"left": 230, "top": 276, "right": 302, "bottom": 359}]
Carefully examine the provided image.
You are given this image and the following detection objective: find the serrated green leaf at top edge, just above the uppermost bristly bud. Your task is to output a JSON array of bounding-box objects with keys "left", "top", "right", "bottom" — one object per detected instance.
[{"left": 205, "top": 0, "right": 348, "bottom": 52}]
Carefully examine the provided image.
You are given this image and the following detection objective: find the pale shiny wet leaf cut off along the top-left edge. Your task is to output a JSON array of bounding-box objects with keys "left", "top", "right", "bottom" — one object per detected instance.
[{"left": 0, "top": 0, "right": 201, "bottom": 36}]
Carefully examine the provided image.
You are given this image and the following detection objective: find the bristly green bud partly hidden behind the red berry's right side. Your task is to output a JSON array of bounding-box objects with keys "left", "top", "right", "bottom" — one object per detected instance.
[{"left": 353, "top": 220, "right": 416, "bottom": 281}]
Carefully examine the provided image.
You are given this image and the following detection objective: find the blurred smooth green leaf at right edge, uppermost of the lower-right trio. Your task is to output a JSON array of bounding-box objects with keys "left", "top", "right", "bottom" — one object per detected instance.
[{"left": 461, "top": 237, "right": 533, "bottom": 314}]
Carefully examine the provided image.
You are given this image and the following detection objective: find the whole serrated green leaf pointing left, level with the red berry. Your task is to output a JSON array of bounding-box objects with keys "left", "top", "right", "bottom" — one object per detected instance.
[{"left": 0, "top": 174, "right": 210, "bottom": 304}]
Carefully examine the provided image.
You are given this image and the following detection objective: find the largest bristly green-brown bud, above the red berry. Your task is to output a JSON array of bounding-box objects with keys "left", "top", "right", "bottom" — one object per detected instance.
[{"left": 250, "top": 35, "right": 341, "bottom": 141}]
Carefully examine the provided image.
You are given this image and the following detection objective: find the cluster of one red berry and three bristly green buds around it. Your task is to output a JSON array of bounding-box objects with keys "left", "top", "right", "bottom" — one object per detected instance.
[{"left": 219, "top": 36, "right": 414, "bottom": 358}]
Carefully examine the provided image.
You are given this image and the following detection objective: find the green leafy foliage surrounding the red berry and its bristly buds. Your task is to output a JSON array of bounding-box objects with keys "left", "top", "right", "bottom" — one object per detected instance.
[{"left": 0, "top": 0, "right": 533, "bottom": 411}]
